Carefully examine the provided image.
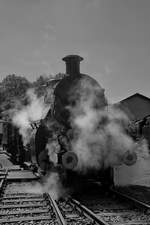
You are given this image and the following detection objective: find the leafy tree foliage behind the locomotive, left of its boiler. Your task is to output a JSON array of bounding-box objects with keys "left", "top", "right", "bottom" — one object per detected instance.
[{"left": 0, "top": 73, "right": 65, "bottom": 116}]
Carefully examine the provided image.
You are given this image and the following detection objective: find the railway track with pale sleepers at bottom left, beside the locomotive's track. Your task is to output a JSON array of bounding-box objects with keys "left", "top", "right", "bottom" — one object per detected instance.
[{"left": 0, "top": 174, "right": 65, "bottom": 225}]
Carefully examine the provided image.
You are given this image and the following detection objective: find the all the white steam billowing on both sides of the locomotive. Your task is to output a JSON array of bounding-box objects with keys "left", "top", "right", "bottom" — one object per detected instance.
[{"left": 9, "top": 75, "right": 148, "bottom": 195}]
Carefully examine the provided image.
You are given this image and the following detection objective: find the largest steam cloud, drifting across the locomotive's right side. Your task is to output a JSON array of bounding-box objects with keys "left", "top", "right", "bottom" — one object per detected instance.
[{"left": 69, "top": 79, "right": 148, "bottom": 173}]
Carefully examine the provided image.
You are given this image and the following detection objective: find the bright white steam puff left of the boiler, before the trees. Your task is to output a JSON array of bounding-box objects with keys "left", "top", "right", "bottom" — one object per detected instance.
[{"left": 12, "top": 89, "right": 48, "bottom": 144}]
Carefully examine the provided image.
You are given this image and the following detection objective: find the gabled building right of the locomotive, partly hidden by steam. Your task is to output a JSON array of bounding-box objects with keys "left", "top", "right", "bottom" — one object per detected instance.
[{"left": 114, "top": 93, "right": 150, "bottom": 187}]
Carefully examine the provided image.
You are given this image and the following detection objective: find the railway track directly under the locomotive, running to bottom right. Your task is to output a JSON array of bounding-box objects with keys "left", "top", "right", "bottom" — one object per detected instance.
[{"left": 71, "top": 183, "right": 150, "bottom": 225}]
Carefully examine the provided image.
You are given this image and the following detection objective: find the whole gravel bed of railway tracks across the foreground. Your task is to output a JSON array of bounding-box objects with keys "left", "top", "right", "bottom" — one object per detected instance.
[{"left": 0, "top": 153, "right": 150, "bottom": 225}]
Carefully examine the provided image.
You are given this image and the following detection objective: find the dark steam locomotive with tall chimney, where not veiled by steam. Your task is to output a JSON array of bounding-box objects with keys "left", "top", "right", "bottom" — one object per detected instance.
[{"left": 31, "top": 55, "right": 136, "bottom": 186}]
